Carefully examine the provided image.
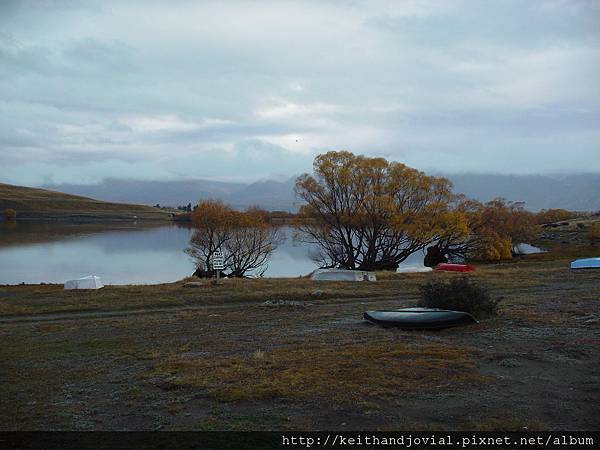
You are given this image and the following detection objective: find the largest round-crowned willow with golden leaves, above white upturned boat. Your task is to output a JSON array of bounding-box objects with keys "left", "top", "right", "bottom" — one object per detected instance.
[{"left": 295, "top": 152, "right": 466, "bottom": 270}]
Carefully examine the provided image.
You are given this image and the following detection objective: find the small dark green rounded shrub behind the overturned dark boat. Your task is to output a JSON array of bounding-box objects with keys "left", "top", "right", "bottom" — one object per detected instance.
[{"left": 418, "top": 277, "right": 500, "bottom": 318}]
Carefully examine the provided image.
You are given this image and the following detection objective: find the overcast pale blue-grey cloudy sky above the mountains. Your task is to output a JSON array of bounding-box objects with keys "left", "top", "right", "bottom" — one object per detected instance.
[{"left": 0, "top": 0, "right": 600, "bottom": 186}]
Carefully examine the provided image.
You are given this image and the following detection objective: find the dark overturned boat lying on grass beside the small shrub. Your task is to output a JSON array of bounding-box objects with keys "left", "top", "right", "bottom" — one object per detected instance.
[{"left": 363, "top": 308, "right": 479, "bottom": 330}]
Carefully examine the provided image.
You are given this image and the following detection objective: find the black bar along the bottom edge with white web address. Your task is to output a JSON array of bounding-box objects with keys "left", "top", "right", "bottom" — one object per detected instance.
[{"left": 0, "top": 431, "right": 600, "bottom": 450}]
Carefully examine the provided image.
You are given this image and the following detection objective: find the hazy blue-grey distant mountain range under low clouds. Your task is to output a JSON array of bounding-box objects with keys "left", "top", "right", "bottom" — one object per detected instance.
[{"left": 43, "top": 173, "right": 600, "bottom": 211}]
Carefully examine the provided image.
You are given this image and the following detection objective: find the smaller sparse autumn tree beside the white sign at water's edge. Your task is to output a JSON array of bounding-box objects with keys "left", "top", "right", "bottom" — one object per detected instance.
[{"left": 186, "top": 200, "right": 282, "bottom": 277}]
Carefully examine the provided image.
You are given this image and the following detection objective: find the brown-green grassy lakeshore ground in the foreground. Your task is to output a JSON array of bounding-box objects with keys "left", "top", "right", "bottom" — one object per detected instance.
[{"left": 0, "top": 250, "right": 600, "bottom": 430}]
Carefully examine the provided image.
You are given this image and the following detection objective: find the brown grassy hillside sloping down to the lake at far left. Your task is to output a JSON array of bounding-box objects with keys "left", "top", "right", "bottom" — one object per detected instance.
[{"left": 0, "top": 183, "right": 171, "bottom": 220}]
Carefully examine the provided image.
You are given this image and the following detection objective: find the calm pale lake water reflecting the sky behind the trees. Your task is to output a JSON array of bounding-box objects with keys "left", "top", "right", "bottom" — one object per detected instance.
[{"left": 0, "top": 222, "right": 539, "bottom": 284}]
